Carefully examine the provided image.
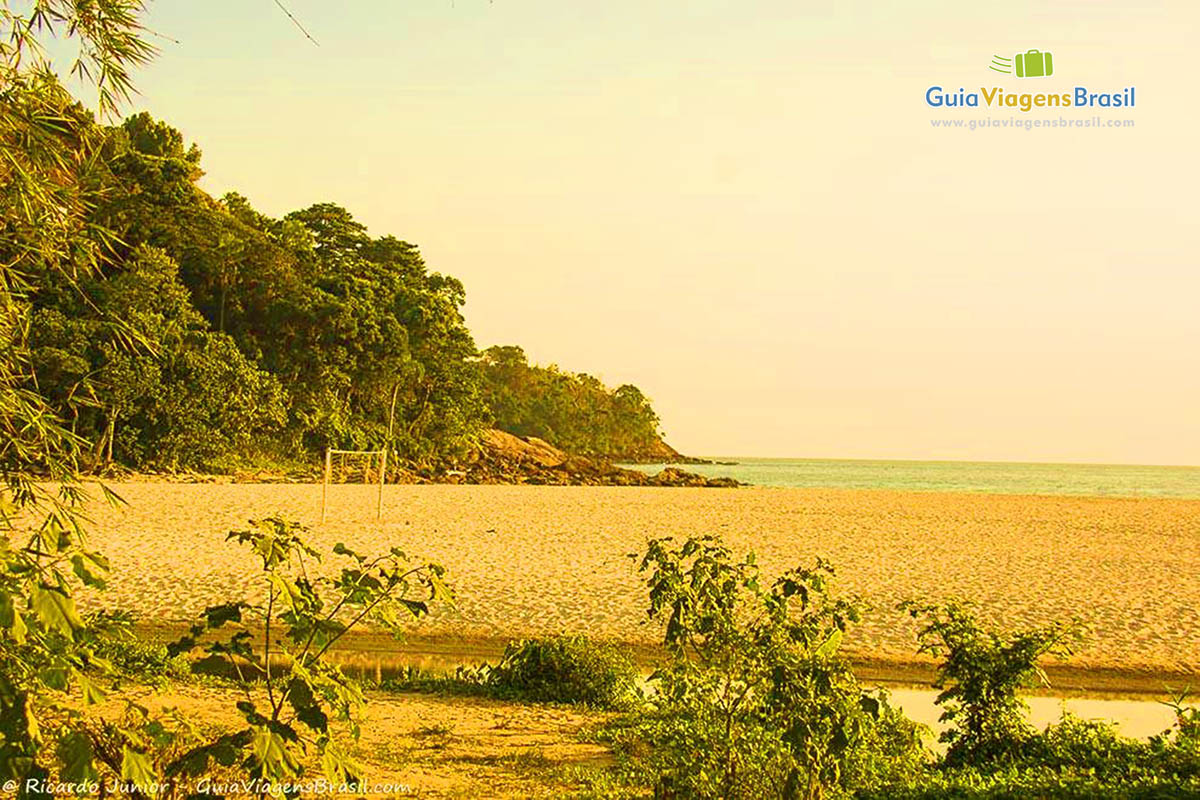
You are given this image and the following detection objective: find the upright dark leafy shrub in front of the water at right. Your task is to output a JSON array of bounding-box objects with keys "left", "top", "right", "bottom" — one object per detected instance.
[{"left": 900, "top": 601, "right": 1079, "bottom": 764}]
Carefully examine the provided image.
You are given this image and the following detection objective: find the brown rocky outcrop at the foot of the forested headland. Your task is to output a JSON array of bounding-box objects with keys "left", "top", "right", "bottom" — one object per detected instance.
[{"left": 458, "top": 428, "right": 740, "bottom": 488}]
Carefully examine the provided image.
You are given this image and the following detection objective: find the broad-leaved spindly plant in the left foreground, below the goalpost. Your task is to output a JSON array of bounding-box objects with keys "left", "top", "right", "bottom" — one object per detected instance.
[{"left": 164, "top": 517, "right": 452, "bottom": 787}]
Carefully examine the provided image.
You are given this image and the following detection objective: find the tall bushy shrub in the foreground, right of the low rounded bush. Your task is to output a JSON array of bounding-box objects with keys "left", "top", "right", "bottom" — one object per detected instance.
[{"left": 618, "top": 537, "right": 928, "bottom": 800}]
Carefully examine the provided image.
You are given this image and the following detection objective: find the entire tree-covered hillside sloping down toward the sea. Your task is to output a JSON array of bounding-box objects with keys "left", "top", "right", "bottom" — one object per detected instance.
[{"left": 21, "top": 110, "right": 676, "bottom": 469}]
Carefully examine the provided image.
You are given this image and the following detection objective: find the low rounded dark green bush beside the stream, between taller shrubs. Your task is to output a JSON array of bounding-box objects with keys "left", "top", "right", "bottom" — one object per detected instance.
[{"left": 487, "top": 636, "right": 637, "bottom": 709}]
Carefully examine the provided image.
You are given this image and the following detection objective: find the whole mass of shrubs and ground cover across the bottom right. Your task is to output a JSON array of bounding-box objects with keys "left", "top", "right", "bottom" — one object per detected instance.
[{"left": 580, "top": 539, "right": 1200, "bottom": 800}]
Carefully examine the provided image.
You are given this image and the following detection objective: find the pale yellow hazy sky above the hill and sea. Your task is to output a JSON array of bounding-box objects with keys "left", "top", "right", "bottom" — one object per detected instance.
[{"left": 126, "top": 0, "right": 1200, "bottom": 464}]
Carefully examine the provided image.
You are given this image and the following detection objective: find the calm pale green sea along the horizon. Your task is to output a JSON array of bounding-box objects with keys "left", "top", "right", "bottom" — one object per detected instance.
[{"left": 629, "top": 458, "right": 1200, "bottom": 499}]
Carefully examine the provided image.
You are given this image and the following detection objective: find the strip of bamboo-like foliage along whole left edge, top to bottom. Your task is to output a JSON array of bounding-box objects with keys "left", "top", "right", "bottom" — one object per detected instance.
[{"left": 0, "top": 0, "right": 152, "bottom": 796}]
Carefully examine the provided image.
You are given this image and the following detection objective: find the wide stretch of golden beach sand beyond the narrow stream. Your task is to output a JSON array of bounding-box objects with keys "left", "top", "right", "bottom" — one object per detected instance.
[{"left": 75, "top": 483, "right": 1200, "bottom": 670}]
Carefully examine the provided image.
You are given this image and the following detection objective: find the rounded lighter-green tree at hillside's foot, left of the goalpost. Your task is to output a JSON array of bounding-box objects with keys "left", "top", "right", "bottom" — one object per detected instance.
[{"left": 32, "top": 246, "right": 286, "bottom": 468}]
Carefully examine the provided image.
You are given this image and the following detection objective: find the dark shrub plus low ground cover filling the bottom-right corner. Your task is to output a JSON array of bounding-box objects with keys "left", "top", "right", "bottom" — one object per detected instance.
[{"left": 859, "top": 602, "right": 1200, "bottom": 800}]
